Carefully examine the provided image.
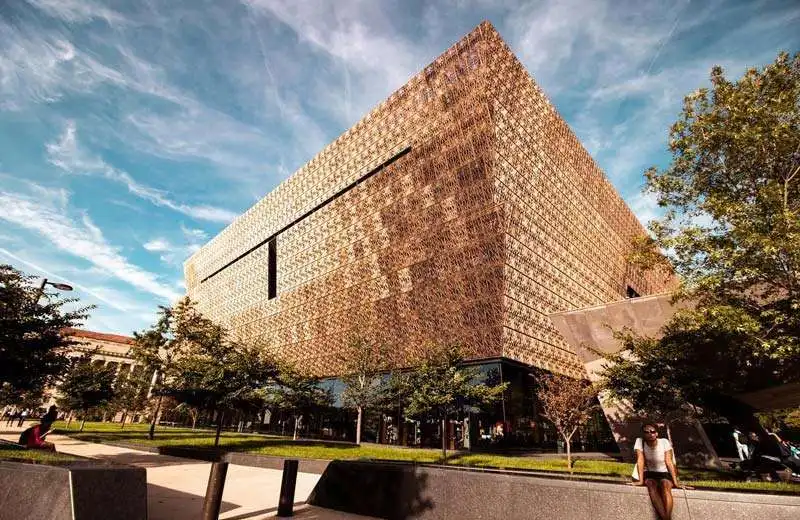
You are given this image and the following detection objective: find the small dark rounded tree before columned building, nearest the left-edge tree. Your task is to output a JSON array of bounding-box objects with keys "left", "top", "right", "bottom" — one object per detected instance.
[{"left": 57, "top": 354, "right": 115, "bottom": 431}]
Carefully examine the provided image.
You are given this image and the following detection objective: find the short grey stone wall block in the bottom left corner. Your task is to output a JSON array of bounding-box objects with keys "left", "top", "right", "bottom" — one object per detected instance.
[{"left": 0, "top": 462, "right": 147, "bottom": 520}]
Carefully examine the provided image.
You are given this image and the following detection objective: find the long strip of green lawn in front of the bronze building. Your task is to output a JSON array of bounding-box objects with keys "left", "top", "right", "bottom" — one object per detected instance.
[{"left": 56, "top": 422, "right": 800, "bottom": 494}]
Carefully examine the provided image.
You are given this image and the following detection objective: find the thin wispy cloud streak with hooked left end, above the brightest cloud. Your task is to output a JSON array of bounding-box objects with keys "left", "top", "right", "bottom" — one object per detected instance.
[{"left": 46, "top": 121, "right": 236, "bottom": 222}]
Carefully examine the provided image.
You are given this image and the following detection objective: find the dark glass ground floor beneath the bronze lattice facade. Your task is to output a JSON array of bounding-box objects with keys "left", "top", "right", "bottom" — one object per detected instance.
[{"left": 259, "top": 359, "right": 618, "bottom": 452}]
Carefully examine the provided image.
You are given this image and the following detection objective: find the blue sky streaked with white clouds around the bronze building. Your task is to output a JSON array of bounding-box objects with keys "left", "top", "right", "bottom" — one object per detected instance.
[{"left": 0, "top": 0, "right": 800, "bottom": 334}]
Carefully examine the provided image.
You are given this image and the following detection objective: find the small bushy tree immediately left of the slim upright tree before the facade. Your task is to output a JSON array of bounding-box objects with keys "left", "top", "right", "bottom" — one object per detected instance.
[{"left": 265, "top": 364, "right": 333, "bottom": 440}]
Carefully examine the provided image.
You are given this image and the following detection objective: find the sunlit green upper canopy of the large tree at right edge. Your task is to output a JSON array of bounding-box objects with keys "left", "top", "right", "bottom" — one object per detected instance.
[{"left": 646, "top": 53, "right": 800, "bottom": 362}]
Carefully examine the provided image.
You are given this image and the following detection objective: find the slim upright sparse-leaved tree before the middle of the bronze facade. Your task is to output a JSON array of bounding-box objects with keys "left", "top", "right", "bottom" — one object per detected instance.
[{"left": 341, "top": 335, "right": 392, "bottom": 444}]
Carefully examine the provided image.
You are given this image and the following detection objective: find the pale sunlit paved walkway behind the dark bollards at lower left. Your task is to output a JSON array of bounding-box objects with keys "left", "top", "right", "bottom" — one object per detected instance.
[{"left": 0, "top": 422, "right": 376, "bottom": 520}]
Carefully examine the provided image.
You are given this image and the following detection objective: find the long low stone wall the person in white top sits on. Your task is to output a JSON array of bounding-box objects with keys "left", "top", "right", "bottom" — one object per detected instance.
[{"left": 308, "top": 461, "right": 800, "bottom": 520}]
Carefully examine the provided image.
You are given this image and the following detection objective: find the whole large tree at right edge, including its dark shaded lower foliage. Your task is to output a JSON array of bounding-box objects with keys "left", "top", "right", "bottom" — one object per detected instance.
[{"left": 606, "top": 53, "right": 800, "bottom": 452}]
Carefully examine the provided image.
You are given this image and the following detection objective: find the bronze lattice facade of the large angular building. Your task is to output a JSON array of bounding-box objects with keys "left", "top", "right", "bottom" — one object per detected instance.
[{"left": 185, "top": 22, "right": 664, "bottom": 376}]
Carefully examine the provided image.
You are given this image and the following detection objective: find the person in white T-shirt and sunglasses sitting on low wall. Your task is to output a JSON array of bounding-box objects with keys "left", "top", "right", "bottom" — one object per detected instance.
[{"left": 631, "top": 423, "right": 684, "bottom": 520}]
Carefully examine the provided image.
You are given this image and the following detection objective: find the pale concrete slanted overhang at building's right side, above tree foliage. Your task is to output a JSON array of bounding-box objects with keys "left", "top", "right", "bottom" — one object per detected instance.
[{"left": 549, "top": 293, "right": 683, "bottom": 363}]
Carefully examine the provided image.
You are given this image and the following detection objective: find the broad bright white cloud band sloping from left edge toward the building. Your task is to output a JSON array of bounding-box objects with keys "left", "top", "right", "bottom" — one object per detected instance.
[{"left": 0, "top": 186, "right": 180, "bottom": 302}]
